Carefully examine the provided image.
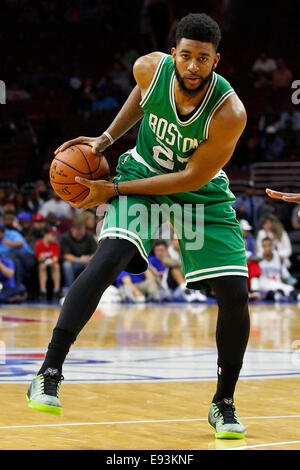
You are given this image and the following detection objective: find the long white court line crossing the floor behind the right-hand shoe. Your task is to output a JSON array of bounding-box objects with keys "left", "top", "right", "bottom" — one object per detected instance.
[{"left": 0, "top": 415, "right": 300, "bottom": 429}]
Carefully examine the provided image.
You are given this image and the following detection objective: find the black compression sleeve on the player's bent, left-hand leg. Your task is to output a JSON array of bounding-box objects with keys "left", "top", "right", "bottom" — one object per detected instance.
[{"left": 39, "top": 238, "right": 137, "bottom": 373}]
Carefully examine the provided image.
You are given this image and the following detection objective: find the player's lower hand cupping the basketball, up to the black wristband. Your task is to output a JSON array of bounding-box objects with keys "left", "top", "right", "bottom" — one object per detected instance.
[{"left": 70, "top": 176, "right": 115, "bottom": 209}]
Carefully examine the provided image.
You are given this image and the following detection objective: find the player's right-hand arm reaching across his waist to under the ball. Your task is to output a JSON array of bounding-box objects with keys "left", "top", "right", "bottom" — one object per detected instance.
[{"left": 74, "top": 95, "right": 247, "bottom": 209}]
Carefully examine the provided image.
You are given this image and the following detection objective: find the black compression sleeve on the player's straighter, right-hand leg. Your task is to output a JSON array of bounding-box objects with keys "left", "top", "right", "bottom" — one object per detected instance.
[{"left": 206, "top": 276, "right": 250, "bottom": 403}]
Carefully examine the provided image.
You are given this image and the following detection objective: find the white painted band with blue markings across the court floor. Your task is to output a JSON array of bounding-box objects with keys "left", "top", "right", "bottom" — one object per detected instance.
[{"left": 0, "top": 347, "right": 300, "bottom": 383}]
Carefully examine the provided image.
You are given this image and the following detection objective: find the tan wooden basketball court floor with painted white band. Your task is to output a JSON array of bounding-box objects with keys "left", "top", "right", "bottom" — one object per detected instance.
[{"left": 0, "top": 304, "right": 300, "bottom": 450}]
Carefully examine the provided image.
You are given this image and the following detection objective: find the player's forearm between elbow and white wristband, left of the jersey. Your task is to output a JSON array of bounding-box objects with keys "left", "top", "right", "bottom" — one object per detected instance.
[{"left": 107, "top": 85, "right": 144, "bottom": 140}]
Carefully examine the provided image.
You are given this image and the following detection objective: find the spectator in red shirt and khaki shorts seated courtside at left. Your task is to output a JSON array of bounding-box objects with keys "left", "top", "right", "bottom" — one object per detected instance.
[{"left": 35, "top": 227, "right": 60, "bottom": 301}]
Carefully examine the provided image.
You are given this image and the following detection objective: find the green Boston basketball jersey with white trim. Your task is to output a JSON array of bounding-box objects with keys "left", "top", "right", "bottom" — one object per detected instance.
[{"left": 131, "top": 55, "right": 235, "bottom": 174}]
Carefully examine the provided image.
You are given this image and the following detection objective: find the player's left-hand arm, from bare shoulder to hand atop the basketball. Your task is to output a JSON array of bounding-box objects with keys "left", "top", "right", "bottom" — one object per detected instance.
[{"left": 55, "top": 52, "right": 164, "bottom": 154}]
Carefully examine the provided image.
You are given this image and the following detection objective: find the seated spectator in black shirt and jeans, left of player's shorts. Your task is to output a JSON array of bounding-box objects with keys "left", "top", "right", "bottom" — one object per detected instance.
[{"left": 60, "top": 218, "right": 97, "bottom": 293}]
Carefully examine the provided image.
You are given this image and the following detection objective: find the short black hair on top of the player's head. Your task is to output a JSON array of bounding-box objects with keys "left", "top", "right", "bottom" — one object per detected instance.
[{"left": 176, "top": 13, "right": 221, "bottom": 50}]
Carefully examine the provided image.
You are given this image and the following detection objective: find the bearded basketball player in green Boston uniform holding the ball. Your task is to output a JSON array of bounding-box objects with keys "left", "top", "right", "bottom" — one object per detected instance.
[{"left": 27, "top": 14, "right": 250, "bottom": 439}]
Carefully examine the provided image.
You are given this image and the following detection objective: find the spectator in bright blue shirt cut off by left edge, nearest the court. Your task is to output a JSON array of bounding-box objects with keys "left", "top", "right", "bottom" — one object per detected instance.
[{"left": 0, "top": 255, "right": 27, "bottom": 303}]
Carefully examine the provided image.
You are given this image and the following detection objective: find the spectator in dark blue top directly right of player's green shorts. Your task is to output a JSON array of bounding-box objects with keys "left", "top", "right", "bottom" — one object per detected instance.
[{"left": 233, "top": 181, "right": 264, "bottom": 231}]
